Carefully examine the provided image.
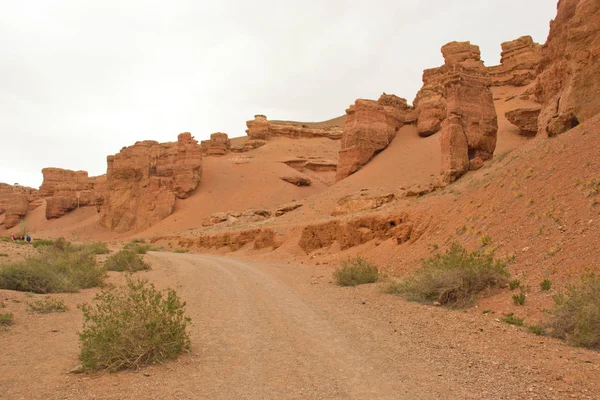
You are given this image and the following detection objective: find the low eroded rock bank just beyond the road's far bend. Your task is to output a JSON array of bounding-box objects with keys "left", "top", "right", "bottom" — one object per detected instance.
[{"left": 156, "top": 228, "right": 283, "bottom": 251}]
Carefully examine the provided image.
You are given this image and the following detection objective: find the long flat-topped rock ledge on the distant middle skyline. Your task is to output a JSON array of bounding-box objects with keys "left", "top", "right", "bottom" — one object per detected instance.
[{"left": 246, "top": 115, "right": 343, "bottom": 140}]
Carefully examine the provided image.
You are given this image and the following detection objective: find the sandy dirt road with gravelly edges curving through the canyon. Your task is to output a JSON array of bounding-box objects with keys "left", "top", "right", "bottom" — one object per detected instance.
[{"left": 0, "top": 253, "right": 600, "bottom": 399}]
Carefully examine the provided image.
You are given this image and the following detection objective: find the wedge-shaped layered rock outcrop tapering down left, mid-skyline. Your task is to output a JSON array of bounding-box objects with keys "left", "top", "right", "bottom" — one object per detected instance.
[{"left": 336, "top": 93, "right": 415, "bottom": 180}]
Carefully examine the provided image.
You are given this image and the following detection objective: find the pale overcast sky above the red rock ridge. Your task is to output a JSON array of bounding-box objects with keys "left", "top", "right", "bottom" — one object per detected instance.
[{"left": 0, "top": 0, "right": 556, "bottom": 187}]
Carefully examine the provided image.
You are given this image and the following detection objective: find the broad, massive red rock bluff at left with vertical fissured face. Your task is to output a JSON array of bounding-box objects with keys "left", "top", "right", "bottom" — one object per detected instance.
[{"left": 100, "top": 132, "right": 202, "bottom": 232}]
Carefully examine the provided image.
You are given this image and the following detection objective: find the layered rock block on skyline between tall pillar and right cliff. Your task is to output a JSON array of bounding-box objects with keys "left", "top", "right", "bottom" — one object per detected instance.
[{"left": 487, "top": 36, "right": 542, "bottom": 86}]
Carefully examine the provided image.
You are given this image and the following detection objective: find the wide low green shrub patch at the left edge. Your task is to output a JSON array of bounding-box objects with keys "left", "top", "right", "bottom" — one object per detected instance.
[{"left": 0, "top": 247, "right": 106, "bottom": 293}]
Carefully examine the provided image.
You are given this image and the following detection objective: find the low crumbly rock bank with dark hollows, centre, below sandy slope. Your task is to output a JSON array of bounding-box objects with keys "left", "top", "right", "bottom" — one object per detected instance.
[{"left": 298, "top": 213, "right": 430, "bottom": 253}]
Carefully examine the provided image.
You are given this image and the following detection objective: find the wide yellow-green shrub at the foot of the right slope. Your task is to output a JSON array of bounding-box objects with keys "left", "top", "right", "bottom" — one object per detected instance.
[{"left": 386, "top": 243, "right": 510, "bottom": 307}]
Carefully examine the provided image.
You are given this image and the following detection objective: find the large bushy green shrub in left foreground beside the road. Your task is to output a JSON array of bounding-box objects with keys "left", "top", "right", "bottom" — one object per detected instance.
[{"left": 79, "top": 277, "right": 190, "bottom": 372}]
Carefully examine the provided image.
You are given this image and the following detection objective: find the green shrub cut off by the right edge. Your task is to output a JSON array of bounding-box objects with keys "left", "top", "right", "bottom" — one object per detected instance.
[{"left": 547, "top": 274, "right": 600, "bottom": 349}]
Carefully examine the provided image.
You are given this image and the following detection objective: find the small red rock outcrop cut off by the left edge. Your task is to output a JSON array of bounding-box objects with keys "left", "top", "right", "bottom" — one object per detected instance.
[{"left": 0, "top": 183, "right": 38, "bottom": 229}]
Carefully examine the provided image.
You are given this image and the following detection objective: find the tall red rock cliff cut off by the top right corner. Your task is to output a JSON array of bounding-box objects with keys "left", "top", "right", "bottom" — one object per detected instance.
[{"left": 535, "top": 0, "right": 600, "bottom": 136}]
